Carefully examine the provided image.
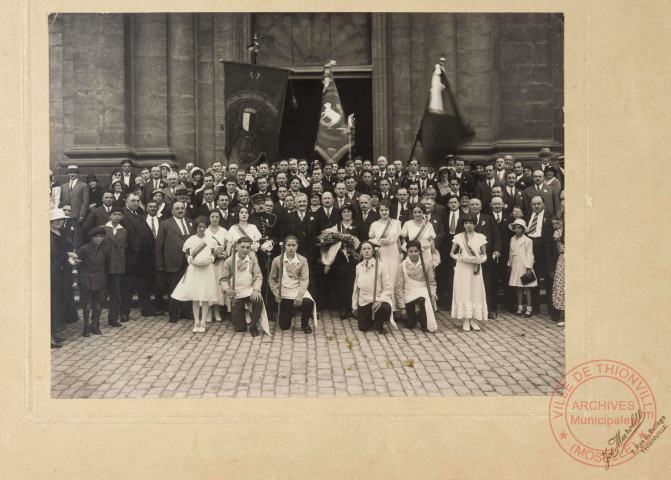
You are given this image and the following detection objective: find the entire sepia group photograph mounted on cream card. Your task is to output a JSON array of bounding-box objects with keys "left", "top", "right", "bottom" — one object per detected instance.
[{"left": 46, "top": 12, "right": 568, "bottom": 399}]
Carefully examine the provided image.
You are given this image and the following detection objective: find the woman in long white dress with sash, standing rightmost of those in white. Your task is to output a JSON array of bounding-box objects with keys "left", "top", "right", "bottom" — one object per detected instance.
[{"left": 450, "top": 214, "right": 488, "bottom": 332}]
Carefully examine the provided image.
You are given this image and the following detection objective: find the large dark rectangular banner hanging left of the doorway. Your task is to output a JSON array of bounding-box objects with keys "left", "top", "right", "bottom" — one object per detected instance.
[{"left": 224, "top": 62, "right": 289, "bottom": 168}]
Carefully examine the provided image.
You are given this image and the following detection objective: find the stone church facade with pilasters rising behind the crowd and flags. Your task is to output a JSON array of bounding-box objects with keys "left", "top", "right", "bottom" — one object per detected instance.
[{"left": 49, "top": 13, "right": 564, "bottom": 173}]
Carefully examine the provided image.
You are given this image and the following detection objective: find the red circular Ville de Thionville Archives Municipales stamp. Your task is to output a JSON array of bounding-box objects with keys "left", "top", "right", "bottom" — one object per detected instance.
[{"left": 549, "top": 360, "right": 657, "bottom": 469}]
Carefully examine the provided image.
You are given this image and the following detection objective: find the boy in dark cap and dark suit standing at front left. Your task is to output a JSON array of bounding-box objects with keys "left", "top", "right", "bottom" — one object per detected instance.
[{"left": 77, "top": 226, "right": 110, "bottom": 337}]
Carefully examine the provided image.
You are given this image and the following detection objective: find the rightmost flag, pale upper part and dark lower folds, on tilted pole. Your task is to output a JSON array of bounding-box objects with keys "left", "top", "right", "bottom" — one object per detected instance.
[{"left": 417, "top": 64, "right": 475, "bottom": 167}]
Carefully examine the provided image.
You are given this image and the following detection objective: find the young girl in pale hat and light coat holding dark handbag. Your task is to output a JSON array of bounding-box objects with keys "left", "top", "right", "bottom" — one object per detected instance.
[{"left": 508, "top": 218, "right": 538, "bottom": 318}]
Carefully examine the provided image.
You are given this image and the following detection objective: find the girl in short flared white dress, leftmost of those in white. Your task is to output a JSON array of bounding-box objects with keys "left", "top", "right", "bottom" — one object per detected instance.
[{"left": 171, "top": 216, "right": 218, "bottom": 333}]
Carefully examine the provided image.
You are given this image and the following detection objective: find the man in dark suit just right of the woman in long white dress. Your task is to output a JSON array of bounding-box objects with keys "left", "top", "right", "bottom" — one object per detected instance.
[{"left": 457, "top": 198, "right": 502, "bottom": 319}]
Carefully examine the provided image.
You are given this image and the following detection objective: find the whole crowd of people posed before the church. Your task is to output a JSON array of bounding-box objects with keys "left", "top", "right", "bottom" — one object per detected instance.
[{"left": 50, "top": 148, "right": 564, "bottom": 348}]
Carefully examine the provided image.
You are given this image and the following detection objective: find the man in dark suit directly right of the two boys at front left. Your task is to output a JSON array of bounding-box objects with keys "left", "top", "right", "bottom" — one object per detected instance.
[{"left": 120, "top": 193, "right": 163, "bottom": 322}]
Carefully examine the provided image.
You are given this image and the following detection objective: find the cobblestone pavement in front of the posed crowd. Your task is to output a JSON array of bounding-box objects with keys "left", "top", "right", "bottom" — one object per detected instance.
[{"left": 51, "top": 310, "right": 564, "bottom": 398}]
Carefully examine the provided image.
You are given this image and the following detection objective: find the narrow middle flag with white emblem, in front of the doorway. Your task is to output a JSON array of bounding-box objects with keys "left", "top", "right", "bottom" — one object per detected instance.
[{"left": 315, "top": 60, "right": 350, "bottom": 163}]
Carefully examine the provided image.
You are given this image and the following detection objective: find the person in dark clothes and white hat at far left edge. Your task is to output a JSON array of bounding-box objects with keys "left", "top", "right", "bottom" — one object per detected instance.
[{"left": 49, "top": 208, "right": 77, "bottom": 348}]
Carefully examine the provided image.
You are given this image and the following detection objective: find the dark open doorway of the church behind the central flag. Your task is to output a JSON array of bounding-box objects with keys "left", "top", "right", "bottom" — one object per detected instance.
[{"left": 280, "top": 77, "right": 373, "bottom": 160}]
